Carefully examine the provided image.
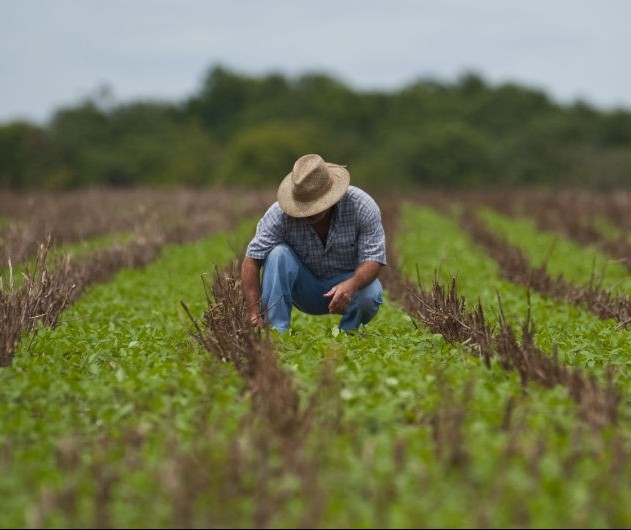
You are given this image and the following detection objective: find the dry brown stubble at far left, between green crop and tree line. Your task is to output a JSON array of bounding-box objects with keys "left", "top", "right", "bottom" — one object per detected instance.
[{"left": 0, "top": 191, "right": 272, "bottom": 366}]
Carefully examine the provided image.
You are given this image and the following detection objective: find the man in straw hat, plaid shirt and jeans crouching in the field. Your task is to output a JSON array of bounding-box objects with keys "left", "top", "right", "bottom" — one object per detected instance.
[{"left": 241, "top": 154, "right": 386, "bottom": 331}]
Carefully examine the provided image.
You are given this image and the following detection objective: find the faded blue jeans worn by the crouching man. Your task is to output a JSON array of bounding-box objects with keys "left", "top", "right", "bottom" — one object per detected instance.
[{"left": 261, "top": 244, "right": 383, "bottom": 331}]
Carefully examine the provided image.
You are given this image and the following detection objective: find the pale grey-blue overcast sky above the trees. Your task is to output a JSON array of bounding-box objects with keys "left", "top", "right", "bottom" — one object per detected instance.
[{"left": 0, "top": 0, "right": 631, "bottom": 123}]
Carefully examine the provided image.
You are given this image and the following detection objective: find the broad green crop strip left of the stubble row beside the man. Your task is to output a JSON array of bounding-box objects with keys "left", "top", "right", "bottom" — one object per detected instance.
[{"left": 0, "top": 235, "right": 244, "bottom": 528}]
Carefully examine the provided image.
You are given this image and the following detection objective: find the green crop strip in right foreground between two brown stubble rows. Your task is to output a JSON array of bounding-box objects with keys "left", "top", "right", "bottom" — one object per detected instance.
[{"left": 266, "top": 300, "right": 629, "bottom": 528}]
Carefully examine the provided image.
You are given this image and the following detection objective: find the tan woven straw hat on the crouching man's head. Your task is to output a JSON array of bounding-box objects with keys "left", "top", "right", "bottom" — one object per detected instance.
[{"left": 277, "top": 154, "right": 351, "bottom": 217}]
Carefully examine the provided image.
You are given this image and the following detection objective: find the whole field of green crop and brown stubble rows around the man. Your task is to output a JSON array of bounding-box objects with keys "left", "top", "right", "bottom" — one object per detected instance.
[{"left": 0, "top": 189, "right": 631, "bottom": 528}]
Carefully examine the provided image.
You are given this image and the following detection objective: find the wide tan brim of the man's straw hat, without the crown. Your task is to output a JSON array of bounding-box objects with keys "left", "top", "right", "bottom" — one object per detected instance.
[{"left": 276, "top": 162, "right": 351, "bottom": 217}]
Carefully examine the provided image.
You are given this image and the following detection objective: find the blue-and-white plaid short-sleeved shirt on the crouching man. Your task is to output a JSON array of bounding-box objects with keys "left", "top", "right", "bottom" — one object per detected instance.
[{"left": 245, "top": 186, "right": 386, "bottom": 278}]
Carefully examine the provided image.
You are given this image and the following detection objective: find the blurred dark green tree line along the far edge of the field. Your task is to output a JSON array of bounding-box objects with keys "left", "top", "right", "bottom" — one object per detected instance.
[{"left": 0, "top": 65, "right": 631, "bottom": 190}]
